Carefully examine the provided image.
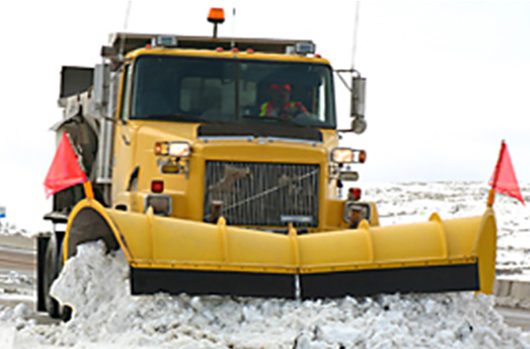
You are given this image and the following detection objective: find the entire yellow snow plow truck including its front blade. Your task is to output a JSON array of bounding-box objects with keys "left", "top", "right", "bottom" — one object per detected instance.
[{"left": 37, "top": 8, "right": 496, "bottom": 317}]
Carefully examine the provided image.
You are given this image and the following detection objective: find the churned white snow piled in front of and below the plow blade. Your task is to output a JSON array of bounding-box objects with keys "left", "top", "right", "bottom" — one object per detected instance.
[{"left": 17, "top": 243, "right": 530, "bottom": 349}]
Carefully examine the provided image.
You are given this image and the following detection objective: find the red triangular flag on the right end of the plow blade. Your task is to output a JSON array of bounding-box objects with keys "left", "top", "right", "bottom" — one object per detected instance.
[{"left": 489, "top": 141, "right": 524, "bottom": 205}]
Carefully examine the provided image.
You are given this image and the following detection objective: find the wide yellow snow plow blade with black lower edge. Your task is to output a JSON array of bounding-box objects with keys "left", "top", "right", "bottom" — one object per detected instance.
[{"left": 63, "top": 200, "right": 497, "bottom": 298}]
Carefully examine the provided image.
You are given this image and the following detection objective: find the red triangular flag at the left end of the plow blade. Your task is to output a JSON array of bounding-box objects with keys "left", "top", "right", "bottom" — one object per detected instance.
[{"left": 44, "top": 132, "right": 88, "bottom": 198}]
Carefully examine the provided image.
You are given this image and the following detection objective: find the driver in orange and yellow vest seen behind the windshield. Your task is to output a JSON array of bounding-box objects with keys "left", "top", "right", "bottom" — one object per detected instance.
[{"left": 259, "top": 83, "right": 308, "bottom": 119}]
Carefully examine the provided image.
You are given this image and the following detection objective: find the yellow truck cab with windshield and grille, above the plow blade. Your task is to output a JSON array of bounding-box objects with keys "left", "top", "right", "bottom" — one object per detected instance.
[{"left": 52, "top": 33, "right": 368, "bottom": 232}]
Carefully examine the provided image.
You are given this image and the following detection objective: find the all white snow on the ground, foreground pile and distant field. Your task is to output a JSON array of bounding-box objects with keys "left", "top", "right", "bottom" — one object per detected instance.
[{"left": 0, "top": 182, "right": 530, "bottom": 349}]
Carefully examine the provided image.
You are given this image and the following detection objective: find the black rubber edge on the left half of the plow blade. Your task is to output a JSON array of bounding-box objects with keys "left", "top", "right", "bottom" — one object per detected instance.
[{"left": 130, "top": 267, "right": 295, "bottom": 298}]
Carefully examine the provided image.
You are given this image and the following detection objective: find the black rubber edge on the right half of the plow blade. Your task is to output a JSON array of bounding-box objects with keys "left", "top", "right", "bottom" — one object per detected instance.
[{"left": 300, "top": 264, "right": 480, "bottom": 299}]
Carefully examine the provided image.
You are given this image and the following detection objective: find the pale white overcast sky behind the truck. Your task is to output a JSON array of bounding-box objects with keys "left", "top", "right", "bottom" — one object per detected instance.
[{"left": 0, "top": 0, "right": 530, "bottom": 230}]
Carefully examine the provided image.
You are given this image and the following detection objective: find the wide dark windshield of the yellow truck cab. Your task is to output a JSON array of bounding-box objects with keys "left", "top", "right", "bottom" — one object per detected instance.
[{"left": 130, "top": 55, "right": 335, "bottom": 128}]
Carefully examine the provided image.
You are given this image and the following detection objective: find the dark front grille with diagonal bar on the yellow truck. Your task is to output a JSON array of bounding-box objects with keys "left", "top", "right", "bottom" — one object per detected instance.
[{"left": 204, "top": 161, "right": 320, "bottom": 227}]
